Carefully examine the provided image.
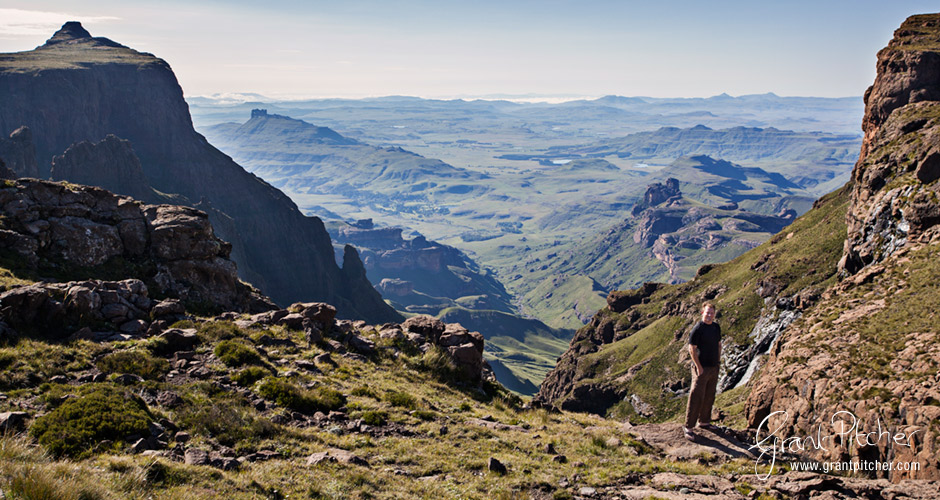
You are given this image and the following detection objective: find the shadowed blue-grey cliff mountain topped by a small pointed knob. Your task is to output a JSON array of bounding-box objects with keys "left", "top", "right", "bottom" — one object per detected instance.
[{"left": 0, "top": 23, "right": 398, "bottom": 321}]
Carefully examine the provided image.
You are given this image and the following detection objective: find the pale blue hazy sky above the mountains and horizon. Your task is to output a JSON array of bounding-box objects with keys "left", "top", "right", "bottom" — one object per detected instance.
[{"left": 0, "top": 0, "right": 938, "bottom": 99}]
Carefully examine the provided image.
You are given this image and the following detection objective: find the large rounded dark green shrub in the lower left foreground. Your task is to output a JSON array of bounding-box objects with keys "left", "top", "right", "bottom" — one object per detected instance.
[{"left": 30, "top": 385, "right": 151, "bottom": 458}]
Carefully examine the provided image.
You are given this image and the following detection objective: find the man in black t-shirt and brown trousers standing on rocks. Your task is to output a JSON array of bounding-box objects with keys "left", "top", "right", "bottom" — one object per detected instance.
[{"left": 683, "top": 302, "right": 721, "bottom": 440}]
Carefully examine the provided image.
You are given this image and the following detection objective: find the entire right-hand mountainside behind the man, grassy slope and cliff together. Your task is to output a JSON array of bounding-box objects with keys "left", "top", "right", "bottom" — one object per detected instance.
[{"left": 538, "top": 14, "right": 940, "bottom": 481}]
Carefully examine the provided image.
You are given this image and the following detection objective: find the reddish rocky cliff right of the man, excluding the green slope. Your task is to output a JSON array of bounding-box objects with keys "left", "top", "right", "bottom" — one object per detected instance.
[{"left": 746, "top": 14, "right": 940, "bottom": 480}]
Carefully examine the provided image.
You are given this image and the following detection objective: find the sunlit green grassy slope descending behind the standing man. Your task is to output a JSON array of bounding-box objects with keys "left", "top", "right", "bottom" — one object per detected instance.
[{"left": 556, "top": 187, "right": 849, "bottom": 421}]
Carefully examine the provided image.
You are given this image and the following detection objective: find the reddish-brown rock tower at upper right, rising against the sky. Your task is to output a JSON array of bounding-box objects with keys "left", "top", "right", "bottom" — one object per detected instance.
[{"left": 839, "top": 15, "right": 940, "bottom": 274}]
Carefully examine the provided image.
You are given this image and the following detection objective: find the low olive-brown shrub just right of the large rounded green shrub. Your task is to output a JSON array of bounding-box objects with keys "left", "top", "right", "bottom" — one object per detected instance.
[{"left": 177, "top": 394, "right": 277, "bottom": 446}]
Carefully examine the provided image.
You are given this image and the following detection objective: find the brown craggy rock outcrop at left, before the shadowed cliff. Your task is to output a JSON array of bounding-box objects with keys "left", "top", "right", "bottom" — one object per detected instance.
[{"left": 0, "top": 179, "right": 270, "bottom": 311}]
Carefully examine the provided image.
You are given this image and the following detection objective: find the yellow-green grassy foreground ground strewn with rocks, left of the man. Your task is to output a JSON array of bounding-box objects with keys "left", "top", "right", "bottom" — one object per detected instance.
[{"left": 0, "top": 323, "right": 753, "bottom": 499}]
